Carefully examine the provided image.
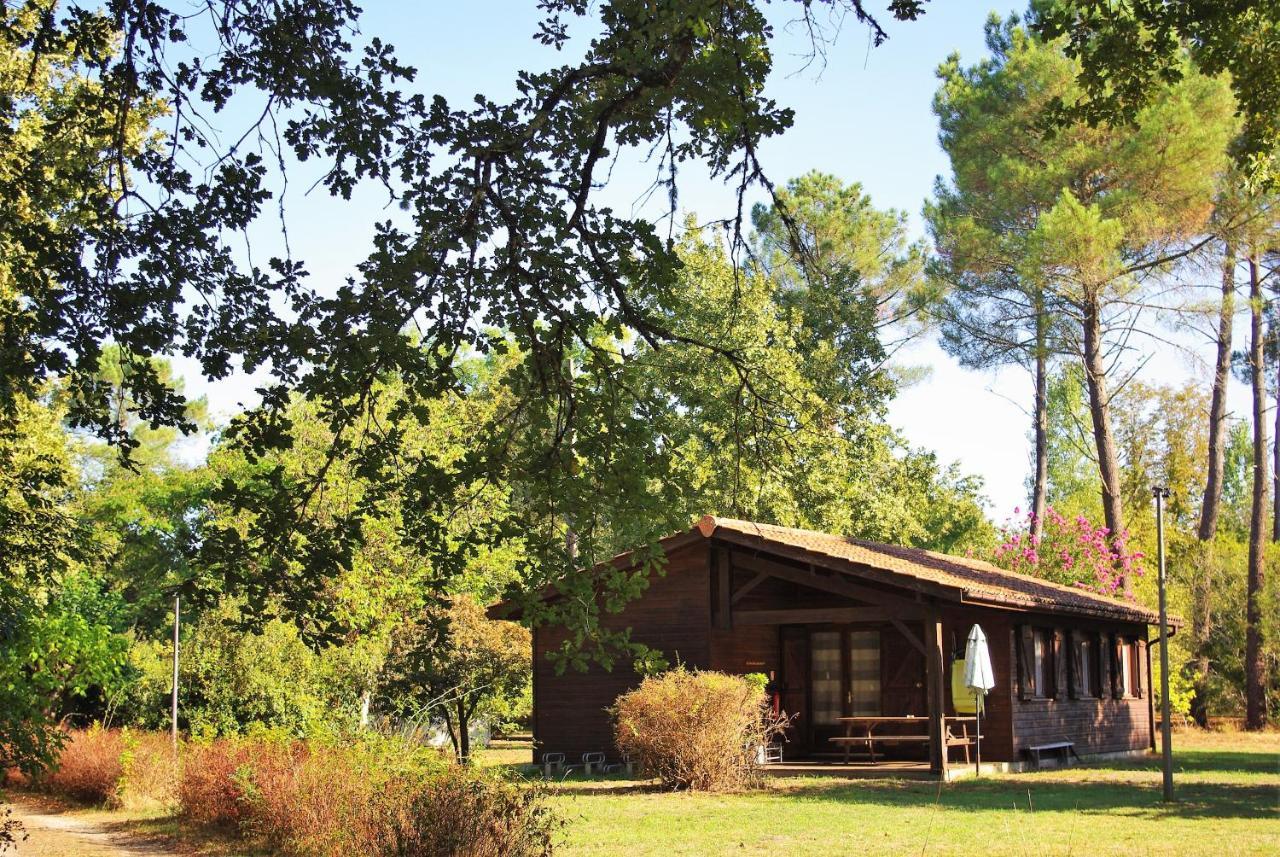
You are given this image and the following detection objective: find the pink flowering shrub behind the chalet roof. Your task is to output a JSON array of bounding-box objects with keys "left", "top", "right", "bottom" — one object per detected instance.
[{"left": 992, "top": 507, "right": 1143, "bottom": 595}]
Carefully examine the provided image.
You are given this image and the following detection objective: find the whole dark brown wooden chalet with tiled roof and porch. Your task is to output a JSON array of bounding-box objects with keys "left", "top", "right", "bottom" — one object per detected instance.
[{"left": 490, "top": 515, "right": 1158, "bottom": 776}]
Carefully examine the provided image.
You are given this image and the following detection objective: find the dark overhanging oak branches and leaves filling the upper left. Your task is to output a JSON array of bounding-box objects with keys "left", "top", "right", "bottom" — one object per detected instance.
[{"left": 0, "top": 0, "right": 922, "bottom": 654}]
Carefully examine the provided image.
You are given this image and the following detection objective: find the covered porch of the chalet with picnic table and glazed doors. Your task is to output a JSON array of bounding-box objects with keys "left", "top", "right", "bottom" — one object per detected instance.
[{"left": 710, "top": 519, "right": 1007, "bottom": 776}]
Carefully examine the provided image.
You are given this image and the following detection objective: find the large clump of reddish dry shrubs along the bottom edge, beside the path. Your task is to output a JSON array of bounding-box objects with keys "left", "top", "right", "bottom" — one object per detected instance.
[{"left": 172, "top": 737, "right": 556, "bottom": 857}]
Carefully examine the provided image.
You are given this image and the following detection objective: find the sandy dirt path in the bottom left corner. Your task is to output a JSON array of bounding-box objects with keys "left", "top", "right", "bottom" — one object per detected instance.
[{"left": 5, "top": 796, "right": 180, "bottom": 857}]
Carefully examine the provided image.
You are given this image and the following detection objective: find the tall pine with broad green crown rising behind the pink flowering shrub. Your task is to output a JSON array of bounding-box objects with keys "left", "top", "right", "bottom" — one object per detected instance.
[{"left": 927, "top": 17, "right": 1235, "bottom": 562}]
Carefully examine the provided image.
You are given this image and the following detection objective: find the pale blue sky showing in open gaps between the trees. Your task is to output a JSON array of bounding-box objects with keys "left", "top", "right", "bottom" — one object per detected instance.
[{"left": 178, "top": 0, "right": 1242, "bottom": 521}]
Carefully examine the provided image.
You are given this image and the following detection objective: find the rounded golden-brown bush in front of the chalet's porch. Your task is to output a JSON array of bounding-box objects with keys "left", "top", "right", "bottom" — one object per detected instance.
[{"left": 612, "top": 666, "right": 785, "bottom": 792}]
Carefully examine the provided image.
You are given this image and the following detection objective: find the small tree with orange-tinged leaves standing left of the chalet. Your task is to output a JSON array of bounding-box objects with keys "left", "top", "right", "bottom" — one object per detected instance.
[{"left": 384, "top": 596, "right": 532, "bottom": 761}]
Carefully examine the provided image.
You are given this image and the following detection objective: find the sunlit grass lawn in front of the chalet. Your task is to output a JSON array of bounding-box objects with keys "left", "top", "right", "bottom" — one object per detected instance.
[{"left": 489, "top": 732, "right": 1280, "bottom": 857}]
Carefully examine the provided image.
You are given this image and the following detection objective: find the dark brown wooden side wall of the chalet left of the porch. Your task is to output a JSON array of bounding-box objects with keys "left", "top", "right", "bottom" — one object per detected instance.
[{"left": 532, "top": 541, "right": 712, "bottom": 762}]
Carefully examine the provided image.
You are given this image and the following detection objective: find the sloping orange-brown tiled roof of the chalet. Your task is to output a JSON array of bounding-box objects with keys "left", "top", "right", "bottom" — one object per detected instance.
[{"left": 698, "top": 515, "right": 1160, "bottom": 624}]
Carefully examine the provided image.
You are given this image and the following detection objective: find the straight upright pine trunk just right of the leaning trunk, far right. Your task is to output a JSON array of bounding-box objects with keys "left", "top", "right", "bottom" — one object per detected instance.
[{"left": 1244, "top": 251, "right": 1268, "bottom": 729}]
